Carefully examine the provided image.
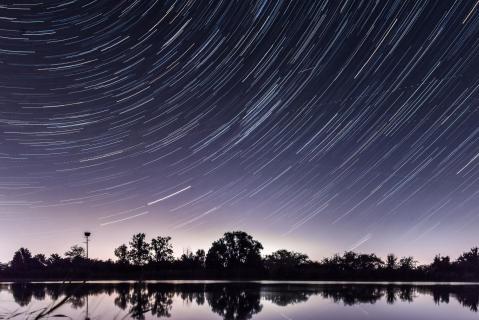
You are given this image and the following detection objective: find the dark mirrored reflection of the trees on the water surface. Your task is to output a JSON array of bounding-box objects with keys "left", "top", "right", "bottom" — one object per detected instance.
[{"left": 0, "top": 282, "right": 479, "bottom": 320}]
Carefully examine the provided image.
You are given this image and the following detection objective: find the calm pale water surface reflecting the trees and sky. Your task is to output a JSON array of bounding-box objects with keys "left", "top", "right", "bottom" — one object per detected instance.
[{"left": 0, "top": 282, "right": 479, "bottom": 320}]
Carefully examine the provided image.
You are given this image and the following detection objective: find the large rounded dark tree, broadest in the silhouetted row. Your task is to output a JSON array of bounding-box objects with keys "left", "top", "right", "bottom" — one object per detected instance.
[{"left": 206, "top": 231, "right": 263, "bottom": 271}]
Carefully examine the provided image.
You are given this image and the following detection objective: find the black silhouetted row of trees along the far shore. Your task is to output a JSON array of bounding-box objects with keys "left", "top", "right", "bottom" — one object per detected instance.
[{"left": 0, "top": 231, "right": 479, "bottom": 281}]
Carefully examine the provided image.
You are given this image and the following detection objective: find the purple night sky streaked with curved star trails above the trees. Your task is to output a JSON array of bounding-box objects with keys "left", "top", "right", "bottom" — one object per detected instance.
[{"left": 0, "top": 0, "right": 479, "bottom": 262}]
